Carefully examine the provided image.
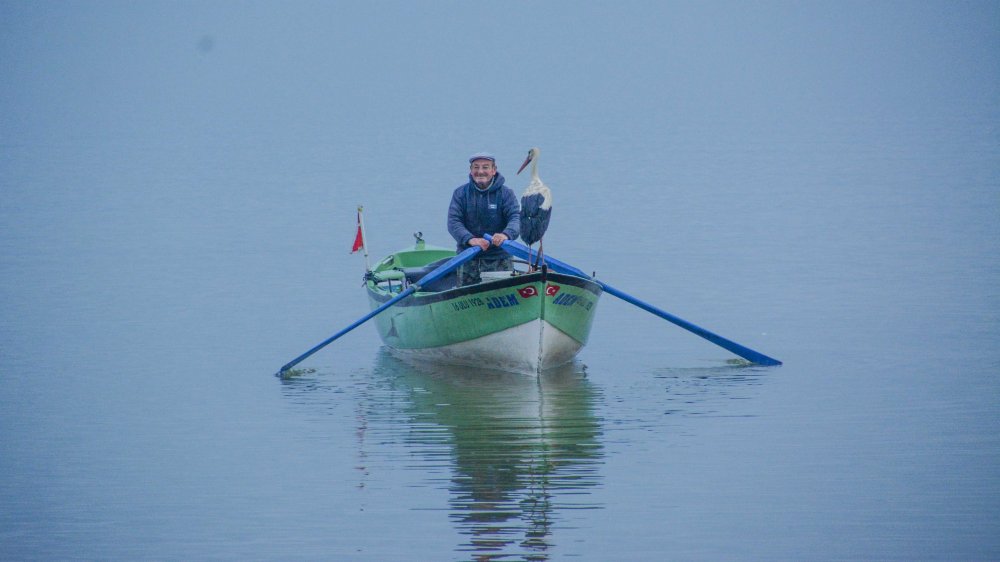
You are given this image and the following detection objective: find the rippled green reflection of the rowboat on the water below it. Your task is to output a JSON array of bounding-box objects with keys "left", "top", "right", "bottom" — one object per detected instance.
[{"left": 380, "top": 356, "right": 602, "bottom": 560}]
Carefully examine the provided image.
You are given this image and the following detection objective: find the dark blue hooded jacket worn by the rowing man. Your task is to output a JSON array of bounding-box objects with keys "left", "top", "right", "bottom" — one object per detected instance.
[{"left": 448, "top": 172, "right": 521, "bottom": 258}]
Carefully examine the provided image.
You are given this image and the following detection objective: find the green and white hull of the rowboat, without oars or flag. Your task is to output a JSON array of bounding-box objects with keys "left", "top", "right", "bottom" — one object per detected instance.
[{"left": 365, "top": 238, "right": 603, "bottom": 374}]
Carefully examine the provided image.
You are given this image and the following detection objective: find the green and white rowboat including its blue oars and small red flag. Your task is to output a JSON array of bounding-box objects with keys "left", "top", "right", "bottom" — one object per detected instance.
[{"left": 275, "top": 219, "right": 781, "bottom": 378}]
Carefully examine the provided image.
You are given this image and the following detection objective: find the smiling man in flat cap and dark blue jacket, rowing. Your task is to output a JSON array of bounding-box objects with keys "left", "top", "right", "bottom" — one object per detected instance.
[{"left": 448, "top": 152, "right": 521, "bottom": 286}]
